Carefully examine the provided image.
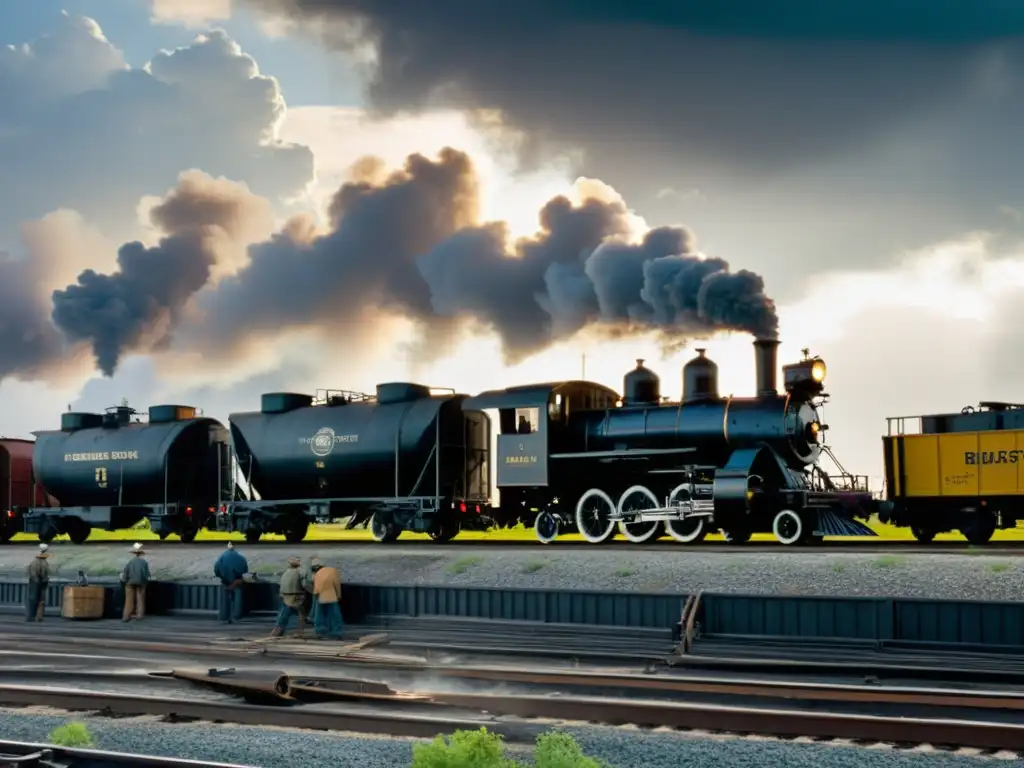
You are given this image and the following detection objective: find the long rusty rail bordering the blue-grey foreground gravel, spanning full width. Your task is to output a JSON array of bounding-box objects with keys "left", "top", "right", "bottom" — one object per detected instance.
[{"left": 0, "top": 686, "right": 1024, "bottom": 750}]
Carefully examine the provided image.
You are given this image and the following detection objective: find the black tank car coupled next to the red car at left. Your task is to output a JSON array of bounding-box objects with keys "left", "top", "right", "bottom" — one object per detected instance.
[{"left": 26, "top": 404, "right": 230, "bottom": 543}]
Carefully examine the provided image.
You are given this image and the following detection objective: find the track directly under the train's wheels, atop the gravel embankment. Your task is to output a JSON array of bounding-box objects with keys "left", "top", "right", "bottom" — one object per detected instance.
[{"left": 6, "top": 537, "right": 1024, "bottom": 555}]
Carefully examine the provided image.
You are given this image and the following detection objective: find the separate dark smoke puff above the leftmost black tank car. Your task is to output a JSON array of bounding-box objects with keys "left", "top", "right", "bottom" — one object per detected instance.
[{"left": 52, "top": 172, "right": 269, "bottom": 376}]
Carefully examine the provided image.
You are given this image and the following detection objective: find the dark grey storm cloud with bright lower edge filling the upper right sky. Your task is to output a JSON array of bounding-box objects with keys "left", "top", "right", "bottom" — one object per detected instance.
[{"left": 237, "top": 0, "right": 1024, "bottom": 288}]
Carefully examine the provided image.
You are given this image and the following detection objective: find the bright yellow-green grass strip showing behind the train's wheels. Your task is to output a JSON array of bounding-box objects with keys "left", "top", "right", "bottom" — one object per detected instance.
[{"left": 14, "top": 520, "right": 1024, "bottom": 555}]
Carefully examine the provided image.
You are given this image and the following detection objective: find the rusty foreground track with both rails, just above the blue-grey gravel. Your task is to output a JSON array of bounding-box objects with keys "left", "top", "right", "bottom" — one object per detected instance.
[{"left": 0, "top": 670, "right": 1024, "bottom": 751}]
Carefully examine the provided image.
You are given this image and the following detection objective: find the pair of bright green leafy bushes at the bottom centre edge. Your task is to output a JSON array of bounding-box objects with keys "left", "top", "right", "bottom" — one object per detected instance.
[{"left": 413, "top": 727, "right": 606, "bottom": 768}]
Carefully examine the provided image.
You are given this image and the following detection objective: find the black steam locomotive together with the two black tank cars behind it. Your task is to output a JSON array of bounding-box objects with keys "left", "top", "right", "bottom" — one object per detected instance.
[{"left": 14, "top": 340, "right": 873, "bottom": 544}]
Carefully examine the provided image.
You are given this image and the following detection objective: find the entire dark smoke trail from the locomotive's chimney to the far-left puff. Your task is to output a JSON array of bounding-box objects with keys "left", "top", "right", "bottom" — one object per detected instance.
[{"left": 53, "top": 148, "right": 778, "bottom": 375}]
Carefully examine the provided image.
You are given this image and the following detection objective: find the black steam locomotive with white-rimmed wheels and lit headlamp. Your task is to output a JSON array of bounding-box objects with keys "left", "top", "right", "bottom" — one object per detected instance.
[{"left": 463, "top": 340, "right": 874, "bottom": 544}]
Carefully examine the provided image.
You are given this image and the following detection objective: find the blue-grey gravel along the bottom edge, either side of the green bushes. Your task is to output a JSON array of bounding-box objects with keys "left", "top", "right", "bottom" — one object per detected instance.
[{"left": 0, "top": 710, "right": 1024, "bottom": 768}]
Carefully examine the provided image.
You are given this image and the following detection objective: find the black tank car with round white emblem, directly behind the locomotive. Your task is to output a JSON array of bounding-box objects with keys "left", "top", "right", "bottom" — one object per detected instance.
[{"left": 229, "top": 382, "right": 490, "bottom": 541}]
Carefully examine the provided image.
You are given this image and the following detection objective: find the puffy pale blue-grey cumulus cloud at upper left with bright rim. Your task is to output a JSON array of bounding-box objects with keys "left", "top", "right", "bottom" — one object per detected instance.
[{"left": 0, "top": 15, "right": 313, "bottom": 250}]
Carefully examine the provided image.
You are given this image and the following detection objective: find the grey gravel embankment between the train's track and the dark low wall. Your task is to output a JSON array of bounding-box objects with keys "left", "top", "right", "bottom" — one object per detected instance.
[{"left": 0, "top": 543, "right": 1024, "bottom": 600}]
